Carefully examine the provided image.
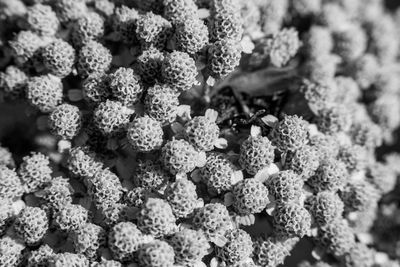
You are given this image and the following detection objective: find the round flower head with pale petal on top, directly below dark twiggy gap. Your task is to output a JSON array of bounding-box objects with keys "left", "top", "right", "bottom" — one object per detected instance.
[{"left": 239, "top": 135, "right": 275, "bottom": 175}]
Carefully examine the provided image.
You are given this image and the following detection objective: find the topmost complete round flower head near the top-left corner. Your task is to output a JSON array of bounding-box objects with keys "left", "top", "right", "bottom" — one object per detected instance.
[{"left": 25, "top": 4, "right": 60, "bottom": 36}]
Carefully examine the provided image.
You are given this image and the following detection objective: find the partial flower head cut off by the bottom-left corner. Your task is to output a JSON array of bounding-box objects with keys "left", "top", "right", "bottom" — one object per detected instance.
[{"left": 0, "top": 236, "right": 25, "bottom": 266}]
